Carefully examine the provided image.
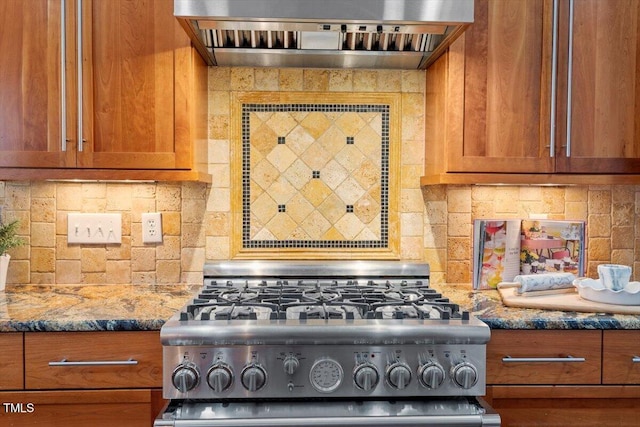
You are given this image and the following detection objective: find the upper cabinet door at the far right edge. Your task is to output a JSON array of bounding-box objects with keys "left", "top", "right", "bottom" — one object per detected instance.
[{"left": 557, "top": 0, "right": 640, "bottom": 173}]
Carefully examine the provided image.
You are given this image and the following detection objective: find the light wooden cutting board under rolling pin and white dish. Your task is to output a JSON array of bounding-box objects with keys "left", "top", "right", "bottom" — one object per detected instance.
[{"left": 498, "top": 287, "right": 640, "bottom": 314}]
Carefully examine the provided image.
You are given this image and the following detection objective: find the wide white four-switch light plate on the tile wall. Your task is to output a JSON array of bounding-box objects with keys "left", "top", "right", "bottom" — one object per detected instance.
[{"left": 67, "top": 213, "right": 122, "bottom": 244}]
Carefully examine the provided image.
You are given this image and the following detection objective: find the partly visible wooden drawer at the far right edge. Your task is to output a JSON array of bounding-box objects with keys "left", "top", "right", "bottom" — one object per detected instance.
[{"left": 602, "top": 331, "right": 640, "bottom": 384}]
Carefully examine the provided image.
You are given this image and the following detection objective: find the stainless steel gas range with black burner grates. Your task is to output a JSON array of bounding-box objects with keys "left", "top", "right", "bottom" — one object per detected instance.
[{"left": 155, "top": 261, "right": 500, "bottom": 427}]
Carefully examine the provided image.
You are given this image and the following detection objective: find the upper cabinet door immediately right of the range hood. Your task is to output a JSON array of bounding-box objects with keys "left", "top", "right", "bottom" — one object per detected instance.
[{"left": 448, "top": 0, "right": 553, "bottom": 173}]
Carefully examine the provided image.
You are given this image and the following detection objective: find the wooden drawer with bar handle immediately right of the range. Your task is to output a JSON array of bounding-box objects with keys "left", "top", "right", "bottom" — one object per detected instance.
[{"left": 487, "top": 330, "right": 602, "bottom": 384}]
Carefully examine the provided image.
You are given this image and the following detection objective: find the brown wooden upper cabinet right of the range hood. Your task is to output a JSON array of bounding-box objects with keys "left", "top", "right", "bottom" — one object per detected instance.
[{"left": 422, "top": 0, "right": 640, "bottom": 184}]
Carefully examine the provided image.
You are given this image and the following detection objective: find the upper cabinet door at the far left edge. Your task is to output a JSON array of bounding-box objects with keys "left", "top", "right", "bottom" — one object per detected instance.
[{"left": 0, "top": 0, "right": 75, "bottom": 167}]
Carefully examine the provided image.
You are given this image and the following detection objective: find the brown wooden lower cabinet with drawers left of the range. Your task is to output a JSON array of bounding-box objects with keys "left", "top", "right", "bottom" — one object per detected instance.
[{"left": 0, "top": 331, "right": 165, "bottom": 427}]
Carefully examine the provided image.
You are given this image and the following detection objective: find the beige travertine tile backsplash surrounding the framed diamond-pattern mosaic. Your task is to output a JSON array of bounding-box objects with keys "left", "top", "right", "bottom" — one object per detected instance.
[{"left": 0, "top": 68, "right": 640, "bottom": 284}]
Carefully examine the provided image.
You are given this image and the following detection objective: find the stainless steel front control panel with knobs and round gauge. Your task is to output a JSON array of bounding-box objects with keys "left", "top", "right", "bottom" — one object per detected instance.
[{"left": 163, "top": 344, "right": 486, "bottom": 399}]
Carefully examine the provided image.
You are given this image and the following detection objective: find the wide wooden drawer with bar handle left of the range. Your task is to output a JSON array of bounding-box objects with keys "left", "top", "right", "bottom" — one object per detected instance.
[{"left": 25, "top": 331, "right": 162, "bottom": 389}]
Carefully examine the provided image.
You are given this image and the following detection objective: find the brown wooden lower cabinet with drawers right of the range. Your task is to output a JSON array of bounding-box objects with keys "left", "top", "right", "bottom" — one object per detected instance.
[{"left": 485, "top": 330, "right": 640, "bottom": 427}]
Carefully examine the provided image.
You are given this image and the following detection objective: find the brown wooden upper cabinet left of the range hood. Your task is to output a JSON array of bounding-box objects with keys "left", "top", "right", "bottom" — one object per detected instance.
[{"left": 0, "top": 0, "right": 206, "bottom": 179}]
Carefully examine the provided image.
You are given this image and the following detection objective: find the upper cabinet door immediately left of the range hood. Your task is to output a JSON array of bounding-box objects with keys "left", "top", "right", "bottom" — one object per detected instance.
[{"left": 78, "top": 0, "right": 191, "bottom": 169}]
